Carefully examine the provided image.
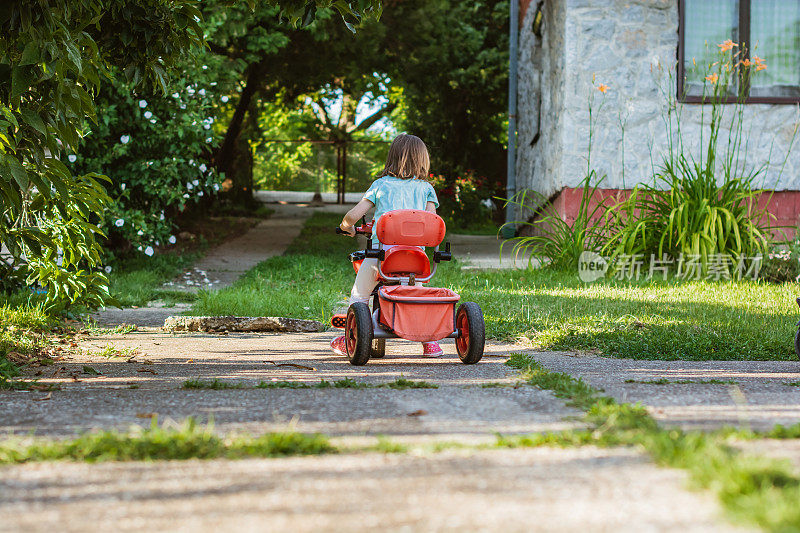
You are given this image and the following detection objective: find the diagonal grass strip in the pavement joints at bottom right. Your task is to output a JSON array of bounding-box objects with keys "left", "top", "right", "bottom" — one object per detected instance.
[{"left": 498, "top": 356, "right": 800, "bottom": 531}]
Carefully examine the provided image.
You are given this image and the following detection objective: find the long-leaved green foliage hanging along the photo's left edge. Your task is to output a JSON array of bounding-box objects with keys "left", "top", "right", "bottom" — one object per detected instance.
[{"left": 0, "top": 0, "right": 212, "bottom": 309}]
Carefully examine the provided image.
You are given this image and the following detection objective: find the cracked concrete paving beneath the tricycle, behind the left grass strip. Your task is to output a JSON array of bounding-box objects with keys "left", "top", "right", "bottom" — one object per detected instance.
[{"left": 0, "top": 331, "right": 580, "bottom": 438}]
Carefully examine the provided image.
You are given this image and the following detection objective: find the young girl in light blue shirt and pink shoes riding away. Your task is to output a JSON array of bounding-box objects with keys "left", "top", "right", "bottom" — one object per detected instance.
[{"left": 331, "top": 134, "right": 442, "bottom": 357}]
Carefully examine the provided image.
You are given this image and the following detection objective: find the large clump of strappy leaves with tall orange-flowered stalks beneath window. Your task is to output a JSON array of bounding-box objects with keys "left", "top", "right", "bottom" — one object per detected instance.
[{"left": 604, "top": 41, "right": 796, "bottom": 273}]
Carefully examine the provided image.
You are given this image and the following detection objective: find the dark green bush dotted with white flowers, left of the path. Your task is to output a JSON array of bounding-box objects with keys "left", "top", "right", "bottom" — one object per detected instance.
[{"left": 67, "top": 68, "right": 222, "bottom": 257}]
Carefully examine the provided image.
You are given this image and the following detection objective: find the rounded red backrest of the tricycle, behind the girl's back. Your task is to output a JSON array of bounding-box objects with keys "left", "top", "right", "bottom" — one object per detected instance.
[{"left": 376, "top": 209, "right": 447, "bottom": 246}]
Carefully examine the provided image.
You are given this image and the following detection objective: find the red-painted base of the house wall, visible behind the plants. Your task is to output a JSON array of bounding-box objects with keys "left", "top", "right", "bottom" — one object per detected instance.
[{"left": 552, "top": 187, "right": 800, "bottom": 238}]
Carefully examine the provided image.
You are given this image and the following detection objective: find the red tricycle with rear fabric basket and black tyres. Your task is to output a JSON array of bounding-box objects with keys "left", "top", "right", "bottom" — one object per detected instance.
[{"left": 331, "top": 209, "right": 485, "bottom": 365}]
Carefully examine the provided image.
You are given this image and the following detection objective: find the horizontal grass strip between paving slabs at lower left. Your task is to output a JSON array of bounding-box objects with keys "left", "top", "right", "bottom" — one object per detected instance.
[{"left": 0, "top": 419, "right": 337, "bottom": 464}]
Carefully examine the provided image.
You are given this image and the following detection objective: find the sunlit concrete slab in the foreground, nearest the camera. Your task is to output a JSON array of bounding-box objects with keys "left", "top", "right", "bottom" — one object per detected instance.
[{"left": 0, "top": 447, "right": 735, "bottom": 532}]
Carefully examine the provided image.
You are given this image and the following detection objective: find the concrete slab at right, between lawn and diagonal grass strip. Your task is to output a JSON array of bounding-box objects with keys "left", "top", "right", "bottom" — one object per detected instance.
[{"left": 532, "top": 352, "right": 800, "bottom": 430}]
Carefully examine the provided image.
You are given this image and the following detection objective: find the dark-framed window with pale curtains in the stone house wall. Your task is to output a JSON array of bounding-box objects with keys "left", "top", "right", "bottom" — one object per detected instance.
[{"left": 678, "top": 0, "right": 800, "bottom": 103}]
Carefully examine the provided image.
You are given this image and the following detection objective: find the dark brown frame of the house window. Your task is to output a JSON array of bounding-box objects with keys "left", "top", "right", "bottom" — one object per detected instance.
[{"left": 677, "top": 0, "right": 800, "bottom": 104}]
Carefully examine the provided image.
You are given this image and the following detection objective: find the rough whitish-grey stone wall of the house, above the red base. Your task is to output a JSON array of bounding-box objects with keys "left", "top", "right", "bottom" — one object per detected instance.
[{"left": 517, "top": 0, "right": 800, "bottom": 196}]
